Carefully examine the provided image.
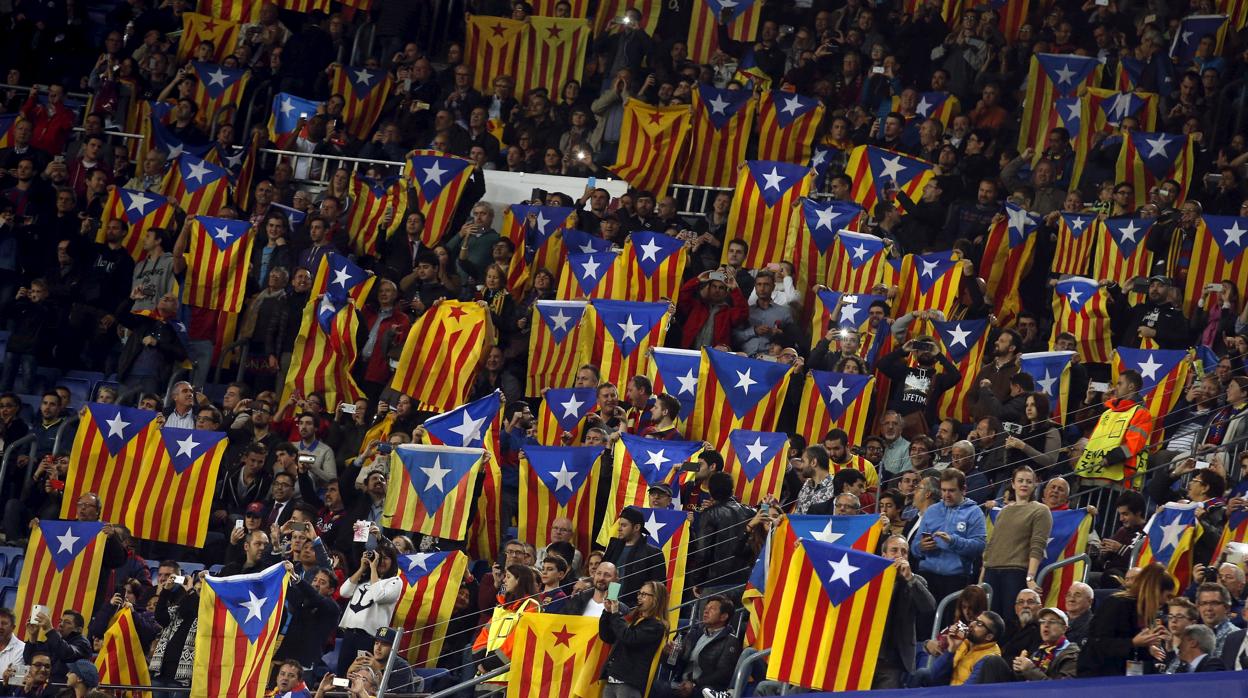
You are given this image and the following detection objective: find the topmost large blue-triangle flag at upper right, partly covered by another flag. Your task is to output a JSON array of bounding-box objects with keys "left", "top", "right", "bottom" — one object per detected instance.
[{"left": 1018, "top": 54, "right": 1101, "bottom": 158}]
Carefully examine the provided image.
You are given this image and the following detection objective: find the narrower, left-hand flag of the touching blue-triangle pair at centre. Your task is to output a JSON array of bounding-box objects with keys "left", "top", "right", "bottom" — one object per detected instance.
[{"left": 524, "top": 301, "right": 585, "bottom": 396}]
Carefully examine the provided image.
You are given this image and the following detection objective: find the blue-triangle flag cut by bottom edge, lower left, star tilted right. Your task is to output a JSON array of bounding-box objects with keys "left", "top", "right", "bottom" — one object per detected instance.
[{"left": 191, "top": 563, "right": 290, "bottom": 698}]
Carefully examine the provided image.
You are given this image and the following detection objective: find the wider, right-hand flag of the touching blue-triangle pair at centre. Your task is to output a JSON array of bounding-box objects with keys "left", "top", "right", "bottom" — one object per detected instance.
[{"left": 582, "top": 300, "right": 670, "bottom": 386}]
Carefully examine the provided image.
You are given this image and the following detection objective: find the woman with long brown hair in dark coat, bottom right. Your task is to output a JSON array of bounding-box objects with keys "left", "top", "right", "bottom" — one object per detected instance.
[{"left": 1080, "top": 562, "right": 1178, "bottom": 677}]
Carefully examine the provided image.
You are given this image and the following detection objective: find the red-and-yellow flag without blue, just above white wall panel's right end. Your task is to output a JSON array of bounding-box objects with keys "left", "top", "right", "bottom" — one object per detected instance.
[{"left": 610, "top": 97, "right": 693, "bottom": 194}]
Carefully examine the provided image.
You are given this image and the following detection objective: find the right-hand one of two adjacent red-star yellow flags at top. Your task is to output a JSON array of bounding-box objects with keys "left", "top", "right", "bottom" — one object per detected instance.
[{"left": 514, "top": 15, "right": 590, "bottom": 95}]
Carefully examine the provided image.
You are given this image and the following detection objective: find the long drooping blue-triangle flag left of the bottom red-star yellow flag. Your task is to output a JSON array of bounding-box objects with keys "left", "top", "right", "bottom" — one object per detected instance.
[{"left": 391, "top": 554, "right": 469, "bottom": 669}]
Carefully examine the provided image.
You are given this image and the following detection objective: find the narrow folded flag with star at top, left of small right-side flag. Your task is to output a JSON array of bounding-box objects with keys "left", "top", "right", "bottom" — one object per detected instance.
[{"left": 980, "top": 201, "right": 1040, "bottom": 327}]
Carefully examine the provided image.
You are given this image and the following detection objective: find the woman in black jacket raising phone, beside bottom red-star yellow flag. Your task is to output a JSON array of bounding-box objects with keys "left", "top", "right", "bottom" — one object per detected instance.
[{"left": 598, "top": 582, "right": 668, "bottom": 698}]
